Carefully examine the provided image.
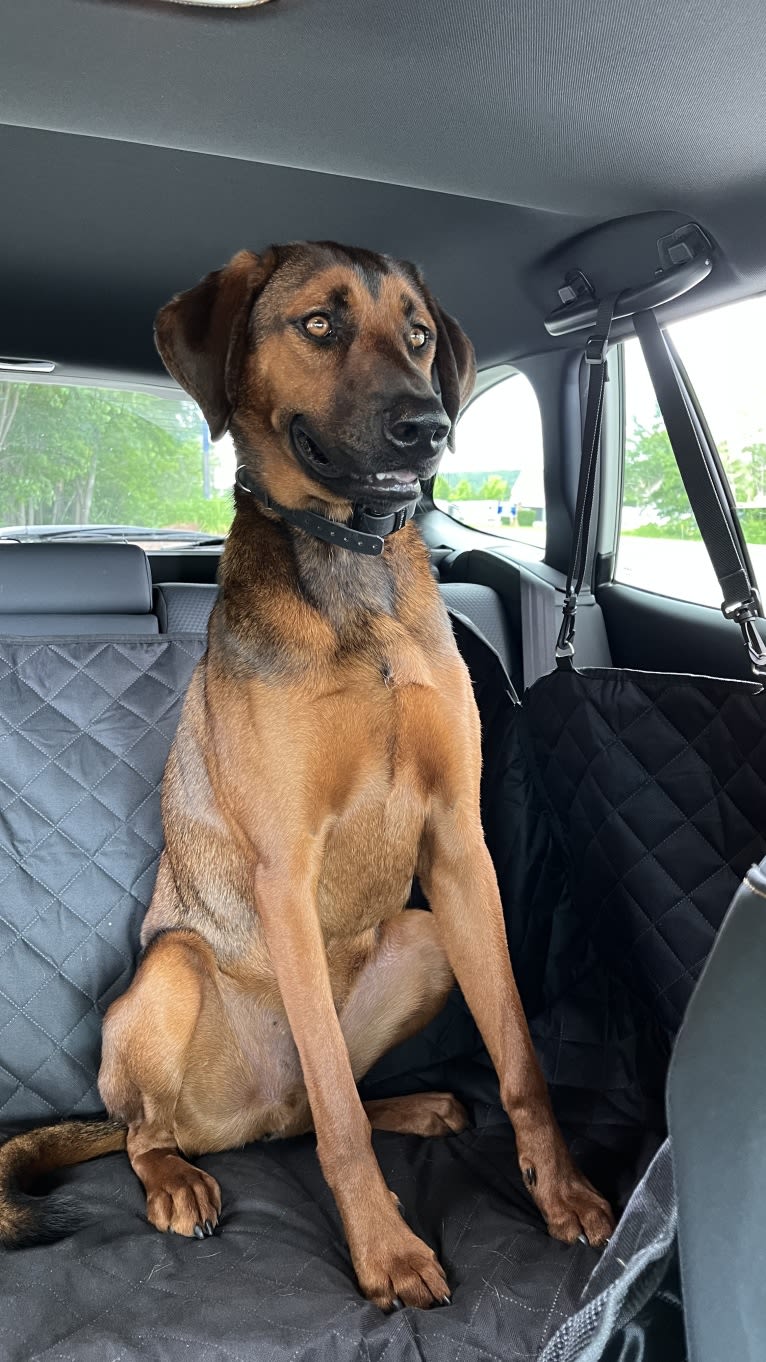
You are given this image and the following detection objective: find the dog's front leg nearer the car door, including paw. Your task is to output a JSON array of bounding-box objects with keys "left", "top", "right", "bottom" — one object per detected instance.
[{"left": 420, "top": 801, "right": 613, "bottom": 1245}]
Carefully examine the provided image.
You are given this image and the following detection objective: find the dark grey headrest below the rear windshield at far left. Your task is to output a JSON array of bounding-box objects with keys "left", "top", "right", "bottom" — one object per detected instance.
[{"left": 0, "top": 543, "right": 151, "bottom": 616}]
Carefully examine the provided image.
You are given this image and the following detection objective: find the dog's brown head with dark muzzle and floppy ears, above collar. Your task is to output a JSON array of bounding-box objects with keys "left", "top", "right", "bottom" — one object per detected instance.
[{"left": 155, "top": 242, "right": 476, "bottom": 509}]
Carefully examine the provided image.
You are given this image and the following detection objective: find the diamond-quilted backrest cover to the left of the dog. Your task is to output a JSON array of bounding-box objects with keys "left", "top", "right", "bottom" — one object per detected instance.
[{"left": 0, "top": 639, "right": 203, "bottom": 1120}]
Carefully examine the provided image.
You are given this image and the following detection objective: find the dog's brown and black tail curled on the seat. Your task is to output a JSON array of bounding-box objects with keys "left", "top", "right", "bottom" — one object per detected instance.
[{"left": 0, "top": 1121, "right": 128, "bottom": 1249}]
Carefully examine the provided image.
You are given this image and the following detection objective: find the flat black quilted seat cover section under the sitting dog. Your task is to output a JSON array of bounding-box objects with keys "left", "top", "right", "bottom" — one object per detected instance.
[{"left": 0, "top": 1124, "right": 607, "bottom": 1362}]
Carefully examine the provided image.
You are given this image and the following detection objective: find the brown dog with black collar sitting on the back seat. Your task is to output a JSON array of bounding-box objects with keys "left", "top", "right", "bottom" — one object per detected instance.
[{"left": 0, "top": 244, "right": 612, "bottom": 1308}]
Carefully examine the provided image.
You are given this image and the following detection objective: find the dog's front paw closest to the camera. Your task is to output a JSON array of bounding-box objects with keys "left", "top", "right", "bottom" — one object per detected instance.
[{"left": 352, "top": 1216, "right": 450, "bottom": 1310}]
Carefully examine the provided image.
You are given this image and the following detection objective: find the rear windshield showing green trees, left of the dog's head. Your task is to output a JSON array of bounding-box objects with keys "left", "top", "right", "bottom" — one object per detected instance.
[{"left": 0, "top": 381, "right": 234, "bottom": 534}]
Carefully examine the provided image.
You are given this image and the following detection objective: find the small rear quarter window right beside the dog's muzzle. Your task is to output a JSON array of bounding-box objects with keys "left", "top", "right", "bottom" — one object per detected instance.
[{"left": 433, "top": 373, "right": 545, "bottom": 556}]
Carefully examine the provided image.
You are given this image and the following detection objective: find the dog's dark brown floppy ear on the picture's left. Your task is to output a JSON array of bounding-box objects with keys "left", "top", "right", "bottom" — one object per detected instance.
[{"left": 154, "top": 249, "right": 278, "bottom": 440}]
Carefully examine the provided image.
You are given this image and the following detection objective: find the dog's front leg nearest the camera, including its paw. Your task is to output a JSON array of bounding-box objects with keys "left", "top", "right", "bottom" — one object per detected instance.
[{"left": 255, "top": 865, "right": 450, "bottom": 1309}]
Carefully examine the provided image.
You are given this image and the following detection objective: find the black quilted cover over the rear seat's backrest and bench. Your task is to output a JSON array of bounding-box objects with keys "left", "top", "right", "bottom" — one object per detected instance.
[{"left": 0, "top": 621, "right": 678, "bottom": 1362}]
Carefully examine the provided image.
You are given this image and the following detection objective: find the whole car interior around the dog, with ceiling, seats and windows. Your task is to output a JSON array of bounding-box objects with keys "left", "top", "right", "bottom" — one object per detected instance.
[{"left": 0, "top": 0, "right": 766, "bottom": 1362}]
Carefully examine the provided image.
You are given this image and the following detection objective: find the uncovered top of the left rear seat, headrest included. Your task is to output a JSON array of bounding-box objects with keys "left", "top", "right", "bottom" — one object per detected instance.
[{"left": 0, "top": 543, "right": 159, "bottom": 637}]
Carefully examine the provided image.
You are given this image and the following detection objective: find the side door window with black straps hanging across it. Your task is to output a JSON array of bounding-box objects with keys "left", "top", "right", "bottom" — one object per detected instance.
[{"left": 616, "top": 298, "right": 766, "bottom": 606}]
